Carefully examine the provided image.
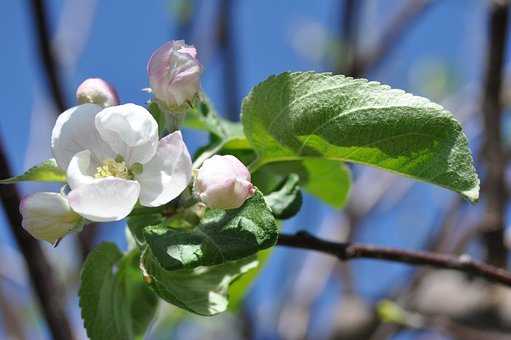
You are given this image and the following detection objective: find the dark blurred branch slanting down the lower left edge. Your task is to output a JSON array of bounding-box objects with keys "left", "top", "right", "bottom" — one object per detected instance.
[{"left": 0, "top": 137, "right": 74, "bottom": 340}]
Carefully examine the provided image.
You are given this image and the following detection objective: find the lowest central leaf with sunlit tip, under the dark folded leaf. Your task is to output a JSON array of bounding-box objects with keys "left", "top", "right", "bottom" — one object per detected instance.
[{"left": 141, "top": 247, "right": 257, "bottom": 316}]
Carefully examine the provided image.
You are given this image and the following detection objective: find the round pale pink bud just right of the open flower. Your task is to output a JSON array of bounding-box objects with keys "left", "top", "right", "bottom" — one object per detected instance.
[{"left": 195, "top": 155, "right": 255, "bottom": 209}]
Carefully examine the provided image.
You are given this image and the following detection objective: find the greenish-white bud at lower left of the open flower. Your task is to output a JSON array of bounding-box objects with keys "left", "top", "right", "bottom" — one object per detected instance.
[{"left": 20, "top": 192, "right": 83, "bottom": 244}]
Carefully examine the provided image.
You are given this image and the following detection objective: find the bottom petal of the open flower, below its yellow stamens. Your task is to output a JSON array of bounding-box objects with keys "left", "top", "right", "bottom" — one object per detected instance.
[{"left": 68, "top": 177, "right": 140, "bottom": 222}]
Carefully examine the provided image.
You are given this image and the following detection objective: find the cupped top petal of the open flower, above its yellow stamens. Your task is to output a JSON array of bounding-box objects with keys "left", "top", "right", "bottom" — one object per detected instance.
[{"left": 96, "top": 104, "right": 158, "bottom": 166}]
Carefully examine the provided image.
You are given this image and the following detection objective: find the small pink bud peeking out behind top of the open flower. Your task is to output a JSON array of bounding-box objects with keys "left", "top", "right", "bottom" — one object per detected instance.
[{"left": 76, "top": 78, "right": 119, "bottom": 107}]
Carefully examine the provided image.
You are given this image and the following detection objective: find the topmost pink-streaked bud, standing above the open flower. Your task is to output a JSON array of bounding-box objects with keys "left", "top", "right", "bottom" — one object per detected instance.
[{"left": 147, "top": 40, "right": 202, "bottom": 109}]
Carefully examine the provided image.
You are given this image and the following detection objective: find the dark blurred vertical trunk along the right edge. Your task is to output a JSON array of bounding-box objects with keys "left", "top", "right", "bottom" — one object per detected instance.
[{"left": 482, "top": 1, "right": 509, "bottom": 268}]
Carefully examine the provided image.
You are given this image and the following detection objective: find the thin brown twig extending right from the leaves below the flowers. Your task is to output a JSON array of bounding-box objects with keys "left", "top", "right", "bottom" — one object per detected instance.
[{"left": 277, "top": 231, "right": 511, "bottom": 287}]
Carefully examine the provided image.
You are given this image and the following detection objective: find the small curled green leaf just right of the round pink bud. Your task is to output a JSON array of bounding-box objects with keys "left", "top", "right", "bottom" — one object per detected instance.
[{"left": 264, "top": 174, "right": 302, "bottom": 220}]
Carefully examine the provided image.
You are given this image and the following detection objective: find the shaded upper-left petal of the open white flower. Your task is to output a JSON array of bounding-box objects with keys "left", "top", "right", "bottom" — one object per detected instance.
[{"left": 51, "top": 104, "right": 115, "bottom": 170}]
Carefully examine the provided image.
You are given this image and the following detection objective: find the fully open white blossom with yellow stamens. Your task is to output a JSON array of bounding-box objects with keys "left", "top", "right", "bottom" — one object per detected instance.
[{"left": 51, "top": 104, "right": 192, "bottom": 222}]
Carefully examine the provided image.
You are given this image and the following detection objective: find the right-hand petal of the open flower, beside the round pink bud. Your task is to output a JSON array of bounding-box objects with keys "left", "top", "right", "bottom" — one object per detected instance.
[{"left": 136, "top": 131, "right": 192, "bottom": 207}]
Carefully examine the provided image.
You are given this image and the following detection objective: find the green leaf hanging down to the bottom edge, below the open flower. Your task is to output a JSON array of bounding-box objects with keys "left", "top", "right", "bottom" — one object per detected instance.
[{"left": 79, "top": 243, "right": 157, "bottom": 340}]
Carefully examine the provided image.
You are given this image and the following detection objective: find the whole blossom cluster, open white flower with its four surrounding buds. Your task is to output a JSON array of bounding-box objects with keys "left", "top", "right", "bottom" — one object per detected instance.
[{"left": 20, "top": 41, "right": 255, "bottom": 244}]
